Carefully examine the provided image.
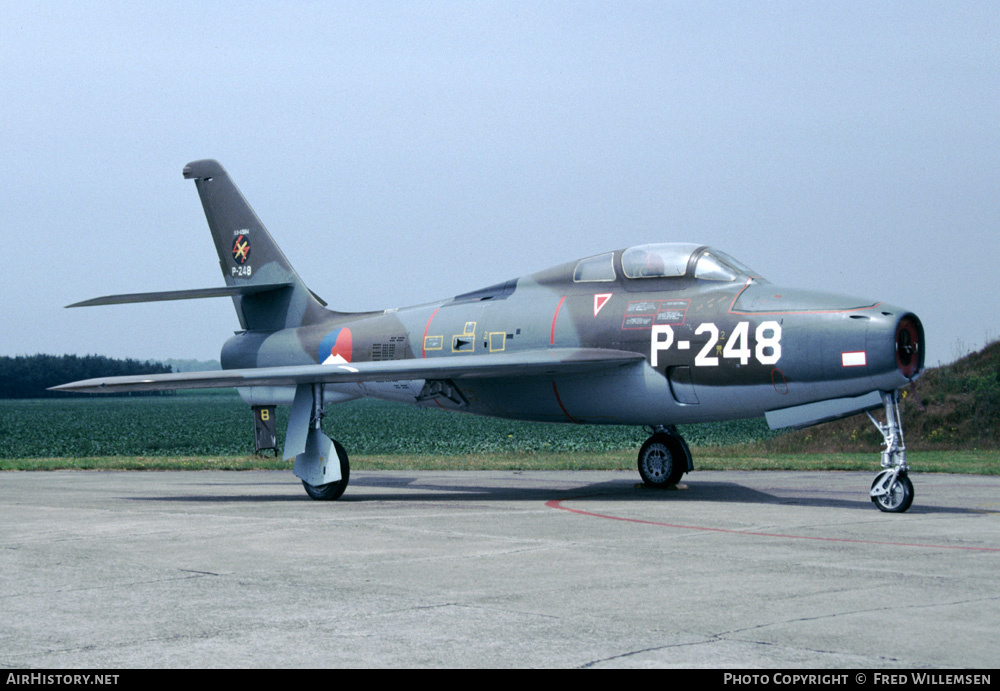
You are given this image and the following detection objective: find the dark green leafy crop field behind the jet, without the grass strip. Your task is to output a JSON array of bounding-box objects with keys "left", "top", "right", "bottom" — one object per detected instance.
[{"left": 0, "top": 394, "right": 773, "bottom": 459}]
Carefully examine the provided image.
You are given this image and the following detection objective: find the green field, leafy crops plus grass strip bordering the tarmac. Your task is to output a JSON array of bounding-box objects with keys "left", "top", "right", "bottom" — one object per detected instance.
[{"left": 0, "top": 394, "right": 1000, "bottom": 474}]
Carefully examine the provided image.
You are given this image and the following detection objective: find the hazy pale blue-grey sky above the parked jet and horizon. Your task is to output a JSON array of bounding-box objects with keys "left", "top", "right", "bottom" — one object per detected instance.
[{"left": 0, "top": 0, "right": 1000, "bottom": 364}]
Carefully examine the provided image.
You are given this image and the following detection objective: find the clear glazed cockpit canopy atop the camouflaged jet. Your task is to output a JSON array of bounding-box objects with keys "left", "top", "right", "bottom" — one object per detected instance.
[{"left": 573, "top": 242, "right": 759, "bottom": 282}]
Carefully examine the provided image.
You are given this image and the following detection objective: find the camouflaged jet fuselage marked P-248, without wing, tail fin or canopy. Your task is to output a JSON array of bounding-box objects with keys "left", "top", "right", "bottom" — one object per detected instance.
[{"left": 222, "top": 251, "right": 922, "bottom": 425}]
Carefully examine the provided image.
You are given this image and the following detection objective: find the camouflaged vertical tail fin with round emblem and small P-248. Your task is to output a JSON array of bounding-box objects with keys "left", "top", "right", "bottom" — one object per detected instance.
[{"left": 184, "top": 160, "right": 326, "bottom": 331}]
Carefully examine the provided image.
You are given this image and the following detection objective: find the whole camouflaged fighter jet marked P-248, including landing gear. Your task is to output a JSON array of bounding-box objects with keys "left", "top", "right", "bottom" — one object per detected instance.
[{"left": 56, "top": 160, "right": 924, "bottom": 512}]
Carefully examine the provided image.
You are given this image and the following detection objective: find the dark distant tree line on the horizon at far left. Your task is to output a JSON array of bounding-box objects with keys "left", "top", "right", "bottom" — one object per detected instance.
[{"left": 0, "top": 354, "right": 172, "bottom": 398}]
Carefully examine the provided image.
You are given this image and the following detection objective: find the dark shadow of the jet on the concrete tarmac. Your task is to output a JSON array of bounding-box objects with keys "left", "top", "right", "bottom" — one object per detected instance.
[{"left": 129, "top": 475, "right": 983, "bottom": 514}]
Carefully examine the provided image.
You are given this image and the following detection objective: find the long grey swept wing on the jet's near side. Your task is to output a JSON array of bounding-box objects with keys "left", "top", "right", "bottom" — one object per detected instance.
[{"left": 51, "top": 348, "right": 645, "bottom": 393}]
